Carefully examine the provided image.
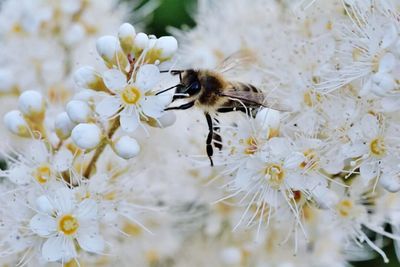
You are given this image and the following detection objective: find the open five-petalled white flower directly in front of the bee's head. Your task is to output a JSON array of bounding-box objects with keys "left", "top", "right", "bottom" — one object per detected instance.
[{"left": 96, "top": 64, "right": 170, "bottom": 133}]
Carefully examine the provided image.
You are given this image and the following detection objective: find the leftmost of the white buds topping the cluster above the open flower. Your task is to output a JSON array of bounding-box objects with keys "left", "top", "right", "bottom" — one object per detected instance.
[{"left": 96, "top": 35, "right": 128, "bottom": 68}]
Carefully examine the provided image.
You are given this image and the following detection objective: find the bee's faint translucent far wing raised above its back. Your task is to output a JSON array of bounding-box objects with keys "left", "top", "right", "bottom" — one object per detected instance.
[{"left": 215, "top": 49, "right": 256, "bottom": 73}]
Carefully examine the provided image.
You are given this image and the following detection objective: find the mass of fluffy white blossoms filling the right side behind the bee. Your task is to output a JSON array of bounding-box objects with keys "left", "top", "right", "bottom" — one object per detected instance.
[{"left": 179, "top": 0, "right": 400, "bottom": 266}]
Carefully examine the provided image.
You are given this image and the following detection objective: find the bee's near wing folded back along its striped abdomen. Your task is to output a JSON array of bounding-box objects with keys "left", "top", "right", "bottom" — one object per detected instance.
[{"left": 220, "top": 89, "right": 292, "bottom": 112}]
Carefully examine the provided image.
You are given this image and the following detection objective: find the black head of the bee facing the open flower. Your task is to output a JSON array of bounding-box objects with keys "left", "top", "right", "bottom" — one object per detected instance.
[{"left": 171, "top": 69, "right": 201, "bottom": 100}]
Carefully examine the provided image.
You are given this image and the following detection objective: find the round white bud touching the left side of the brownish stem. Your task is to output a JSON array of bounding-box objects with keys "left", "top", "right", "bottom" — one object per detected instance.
[{"left": 71, "top": 123, "right": 102, "bottom": 149}]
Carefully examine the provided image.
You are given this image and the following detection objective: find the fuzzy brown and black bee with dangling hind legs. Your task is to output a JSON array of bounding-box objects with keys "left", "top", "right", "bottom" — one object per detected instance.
[{"left": 157, "top": 56, "right": 286, "bottom": 166}]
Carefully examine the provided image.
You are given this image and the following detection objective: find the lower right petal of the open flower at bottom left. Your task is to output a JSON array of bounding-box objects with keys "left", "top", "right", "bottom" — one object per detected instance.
[{"left": 76, "top": 227, "right": 105, "bottom": 253}]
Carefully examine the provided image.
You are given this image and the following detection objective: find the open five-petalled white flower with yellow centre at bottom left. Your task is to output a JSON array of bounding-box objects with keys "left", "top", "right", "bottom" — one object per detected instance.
[{"left": 30, "top": 188, "right": 105, "bottom": 262}]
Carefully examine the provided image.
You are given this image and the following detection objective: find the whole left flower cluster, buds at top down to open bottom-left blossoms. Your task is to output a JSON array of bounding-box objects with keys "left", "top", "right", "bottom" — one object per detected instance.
[{"left": 0, "top": 16, "right": 177, "bottom": 266}]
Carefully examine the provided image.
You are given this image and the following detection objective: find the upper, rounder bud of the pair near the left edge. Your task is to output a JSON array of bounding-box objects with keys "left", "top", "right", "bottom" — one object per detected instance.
[{"left": 18, "top": 90, "right": 46, "bottom": 117}]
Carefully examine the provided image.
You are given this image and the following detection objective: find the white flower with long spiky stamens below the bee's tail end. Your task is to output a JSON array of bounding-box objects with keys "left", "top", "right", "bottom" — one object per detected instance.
[{"left": 220, "top": 137, "right": 312, "bottom": 228}]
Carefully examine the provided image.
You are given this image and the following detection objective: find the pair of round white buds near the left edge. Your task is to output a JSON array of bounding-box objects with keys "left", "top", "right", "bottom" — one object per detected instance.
[{"left": 4, "top": 90, "right": 46, "bottom": 137}]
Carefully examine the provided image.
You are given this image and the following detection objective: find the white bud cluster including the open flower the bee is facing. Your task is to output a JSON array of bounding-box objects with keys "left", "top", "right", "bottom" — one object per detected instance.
[{"left": 63, "top": 23, "right": 177, "bottom": 159}]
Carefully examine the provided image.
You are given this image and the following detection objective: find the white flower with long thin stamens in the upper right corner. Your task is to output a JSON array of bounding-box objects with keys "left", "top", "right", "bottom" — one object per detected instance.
[{"left": 319, "top": 1, "right": 399, "bottom": 96}]
